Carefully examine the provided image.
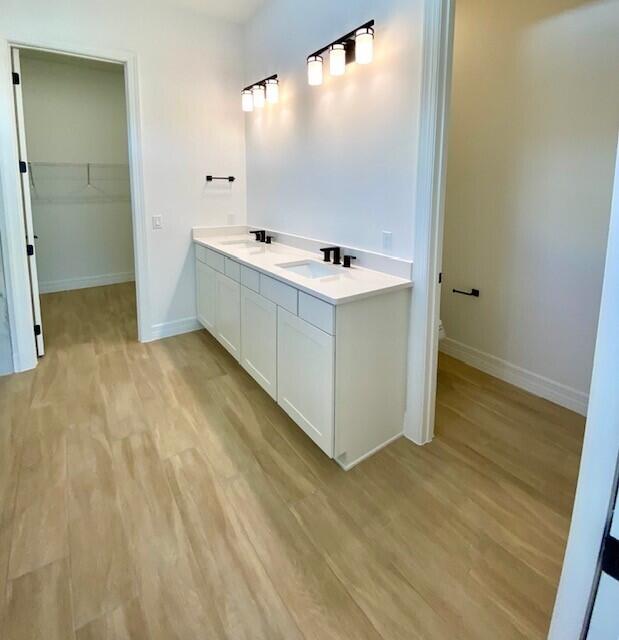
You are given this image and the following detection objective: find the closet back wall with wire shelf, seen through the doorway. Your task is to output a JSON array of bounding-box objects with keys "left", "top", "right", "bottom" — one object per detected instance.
[{"left": 21, "top": 50, "right": 134, "bottom": 293}]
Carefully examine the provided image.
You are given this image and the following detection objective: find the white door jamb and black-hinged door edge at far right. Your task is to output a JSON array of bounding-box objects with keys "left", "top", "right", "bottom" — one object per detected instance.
[{"left": 549, "top": 132, "right": 619, "bottom": 640}]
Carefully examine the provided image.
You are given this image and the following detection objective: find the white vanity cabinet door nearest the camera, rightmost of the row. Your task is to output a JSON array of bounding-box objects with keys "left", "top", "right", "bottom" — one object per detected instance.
[{"left": 277, "top": 307, "right": 335, "bottom": 458}]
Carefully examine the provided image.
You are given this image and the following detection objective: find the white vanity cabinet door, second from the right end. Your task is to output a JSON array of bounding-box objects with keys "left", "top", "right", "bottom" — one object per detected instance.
[{"left": 241, "top": 287, "right": 277, "bottom": 400}]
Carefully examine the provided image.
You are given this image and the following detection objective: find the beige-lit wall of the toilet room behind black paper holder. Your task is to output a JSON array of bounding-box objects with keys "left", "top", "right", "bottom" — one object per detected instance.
[{"left": 442, "top": 0, "right": 619, "bottom": 409}]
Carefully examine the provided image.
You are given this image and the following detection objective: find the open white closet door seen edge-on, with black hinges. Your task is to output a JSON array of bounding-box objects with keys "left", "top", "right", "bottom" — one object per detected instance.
[{"left": 11, "top": 49, "right": 45, "bottom": 357}]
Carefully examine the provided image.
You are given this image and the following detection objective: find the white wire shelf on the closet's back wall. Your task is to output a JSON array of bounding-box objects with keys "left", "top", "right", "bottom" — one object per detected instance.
[{"left": 28, "top": 162, "right": 131, "bottom": 205}]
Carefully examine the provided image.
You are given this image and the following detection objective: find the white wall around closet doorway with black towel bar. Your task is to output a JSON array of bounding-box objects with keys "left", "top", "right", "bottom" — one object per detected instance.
[{"left": 0, "top": 0, "right": 245, "bottom": 356}]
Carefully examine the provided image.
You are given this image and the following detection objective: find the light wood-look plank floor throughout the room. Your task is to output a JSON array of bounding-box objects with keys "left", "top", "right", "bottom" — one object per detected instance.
[{"left": 0, "top": 285, "right": 583, "bottom": 640}]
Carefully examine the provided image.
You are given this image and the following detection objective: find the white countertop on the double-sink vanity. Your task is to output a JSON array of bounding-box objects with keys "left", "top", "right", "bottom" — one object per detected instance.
[{"left": 194, "top": 234, "right": 413, "bottom": 305}]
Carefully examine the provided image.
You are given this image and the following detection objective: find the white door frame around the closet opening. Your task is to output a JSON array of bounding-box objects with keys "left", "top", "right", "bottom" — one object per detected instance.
[{"left": 0, "top": 38, "right": 151, "bottom": 372}]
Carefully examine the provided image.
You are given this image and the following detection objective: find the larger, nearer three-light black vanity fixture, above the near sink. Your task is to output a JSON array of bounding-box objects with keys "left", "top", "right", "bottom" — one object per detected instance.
[{"left": 307, "top": 20, "right": 374, "bottom": 87}]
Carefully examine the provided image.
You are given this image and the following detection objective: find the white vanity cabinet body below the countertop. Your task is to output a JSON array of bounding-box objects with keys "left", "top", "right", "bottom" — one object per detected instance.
[{"left": 196, "top": 245, "right": 411, "bottom": 470}]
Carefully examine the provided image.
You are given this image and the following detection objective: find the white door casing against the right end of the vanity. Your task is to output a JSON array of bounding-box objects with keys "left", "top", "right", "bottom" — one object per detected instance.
[{"left": 404, "top": 0, "right": 455, "bottom": 444}]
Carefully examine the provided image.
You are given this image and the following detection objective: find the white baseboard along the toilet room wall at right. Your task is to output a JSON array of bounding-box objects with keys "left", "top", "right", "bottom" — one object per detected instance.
[{"left": 439, "top": 338, "right": 589, "bottom": 416}]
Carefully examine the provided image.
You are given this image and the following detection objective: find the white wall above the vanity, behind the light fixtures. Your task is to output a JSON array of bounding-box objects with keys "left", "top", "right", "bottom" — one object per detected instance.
[{"left": 245, "top": 0, "right": 423, "bottom": 258}]
